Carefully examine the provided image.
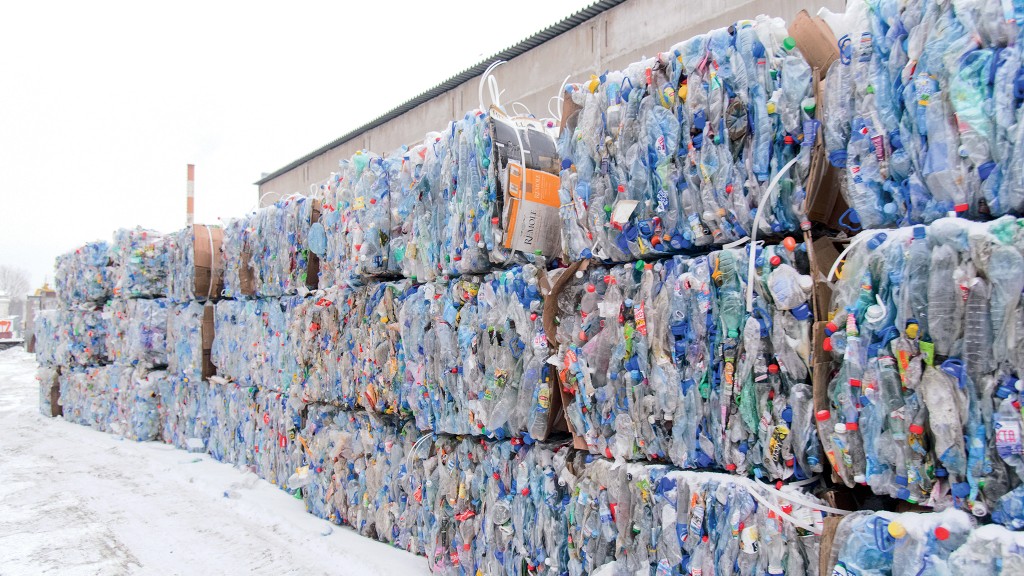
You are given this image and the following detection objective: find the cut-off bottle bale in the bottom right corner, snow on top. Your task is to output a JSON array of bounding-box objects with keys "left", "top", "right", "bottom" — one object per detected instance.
[{"left": 829, "top": 509, "right": 1024, "bottom": 576}]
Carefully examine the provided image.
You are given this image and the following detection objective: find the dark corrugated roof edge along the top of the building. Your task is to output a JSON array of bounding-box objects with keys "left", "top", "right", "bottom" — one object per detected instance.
[{"left": 254, "top": 0, "right": 626, "bottom": 186}]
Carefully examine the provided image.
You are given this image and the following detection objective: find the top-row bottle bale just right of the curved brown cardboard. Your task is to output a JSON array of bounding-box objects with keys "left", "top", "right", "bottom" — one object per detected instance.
[{"left": 222, "top": 195, "right": 313, "bottom": 298}]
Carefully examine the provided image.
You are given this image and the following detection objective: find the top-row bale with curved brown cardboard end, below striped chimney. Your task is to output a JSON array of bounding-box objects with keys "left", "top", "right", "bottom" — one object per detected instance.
[{"left": 167, "top": 224, "right": 224, "bottom": 302}]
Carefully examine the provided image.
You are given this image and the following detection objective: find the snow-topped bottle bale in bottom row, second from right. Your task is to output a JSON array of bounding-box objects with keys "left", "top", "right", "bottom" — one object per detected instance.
[{"left": 559, "top": 454, "right": 824, "bottom": 576}]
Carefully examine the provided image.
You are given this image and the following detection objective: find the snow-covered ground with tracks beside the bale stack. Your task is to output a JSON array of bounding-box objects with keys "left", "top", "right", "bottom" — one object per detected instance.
[{"left": 0, "top": 348, "right": 428, "bottom": 576}]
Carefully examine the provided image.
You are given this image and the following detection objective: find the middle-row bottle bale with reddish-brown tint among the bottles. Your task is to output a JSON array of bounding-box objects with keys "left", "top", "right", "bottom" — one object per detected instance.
[{"left": 288, "top": 281, "right": 410, "bottom": 414}]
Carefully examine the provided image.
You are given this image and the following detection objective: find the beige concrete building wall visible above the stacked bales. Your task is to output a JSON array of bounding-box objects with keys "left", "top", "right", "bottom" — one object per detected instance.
[{"left": 259, "top": 0, "right": 846, "bottom": 205}]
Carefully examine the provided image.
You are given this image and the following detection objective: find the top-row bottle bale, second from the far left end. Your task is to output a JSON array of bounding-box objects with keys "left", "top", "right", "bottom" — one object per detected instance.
[{"left": 111, "top": 228, "right": 171, "bottom": 298}]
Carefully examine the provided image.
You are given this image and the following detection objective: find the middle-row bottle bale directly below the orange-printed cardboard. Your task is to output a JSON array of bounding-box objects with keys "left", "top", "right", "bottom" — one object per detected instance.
[{"left": 399, "top": 264, "right": 551, "bottom": 439}]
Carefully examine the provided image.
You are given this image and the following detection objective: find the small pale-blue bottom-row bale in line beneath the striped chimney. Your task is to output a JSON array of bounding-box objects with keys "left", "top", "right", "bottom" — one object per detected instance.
[{"left": 154, "top": 371, "right": 210, "bottom": 452}]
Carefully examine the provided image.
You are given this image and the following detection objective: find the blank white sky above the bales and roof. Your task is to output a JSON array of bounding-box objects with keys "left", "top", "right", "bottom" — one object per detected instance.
[{"left": 0, "top": 0, "right": 593, "bottom": 286}]
